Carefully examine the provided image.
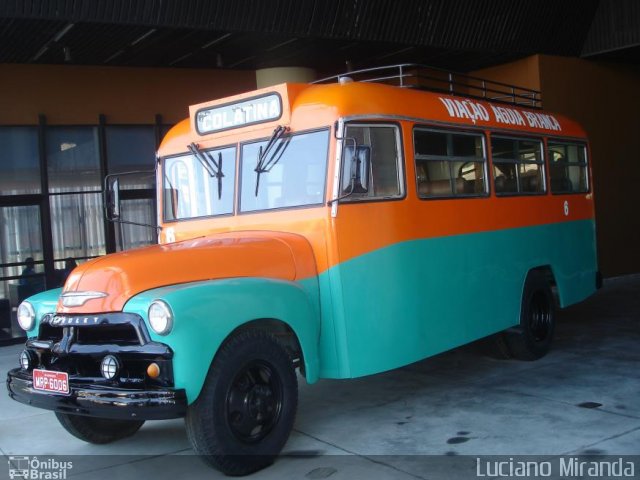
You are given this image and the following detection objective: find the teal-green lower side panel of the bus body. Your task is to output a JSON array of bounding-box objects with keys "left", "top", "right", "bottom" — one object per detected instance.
[{"left": 319, "top": 220, "right": 597, "bottom": 378}]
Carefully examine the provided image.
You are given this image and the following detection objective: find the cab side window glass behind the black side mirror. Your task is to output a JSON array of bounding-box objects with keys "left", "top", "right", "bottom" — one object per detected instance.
[{"left": 341, "top": 124, "right": 404, "bottom": 201}]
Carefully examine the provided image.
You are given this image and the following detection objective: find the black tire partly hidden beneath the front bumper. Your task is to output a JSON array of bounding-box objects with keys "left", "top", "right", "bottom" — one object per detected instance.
[{"left": 56, "top": 412, "right": 144, "bottom": 444}]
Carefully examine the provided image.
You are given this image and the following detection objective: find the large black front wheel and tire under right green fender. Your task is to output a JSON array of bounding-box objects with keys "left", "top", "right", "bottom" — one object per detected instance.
[{"left": 185, "top": 330, "right": 298, "bottom": 476}]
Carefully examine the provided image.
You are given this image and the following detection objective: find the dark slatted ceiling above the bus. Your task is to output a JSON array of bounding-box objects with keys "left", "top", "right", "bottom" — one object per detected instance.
[{"left": 0, "top": 0, "right": 640, "bottom": 71}]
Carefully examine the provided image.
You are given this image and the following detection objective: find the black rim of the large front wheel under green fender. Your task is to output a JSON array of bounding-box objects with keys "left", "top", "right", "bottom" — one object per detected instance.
[{"left": 226, "top": 360, "right": 284, "bottom": 443}]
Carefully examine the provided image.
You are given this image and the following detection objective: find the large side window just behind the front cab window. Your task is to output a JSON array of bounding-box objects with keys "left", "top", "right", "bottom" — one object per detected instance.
[{"left": 413, "top": 128, "right": 487, "bottom": 198}]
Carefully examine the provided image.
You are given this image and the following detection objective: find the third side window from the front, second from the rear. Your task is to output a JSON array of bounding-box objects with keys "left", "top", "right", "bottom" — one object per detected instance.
[{"left": 491, "top": 136, "right": 546, "bottom": 195}]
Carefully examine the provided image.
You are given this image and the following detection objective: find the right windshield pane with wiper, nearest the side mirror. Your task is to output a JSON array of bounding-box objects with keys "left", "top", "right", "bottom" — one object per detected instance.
[{"left": 240, "top": 130, "right": 329, "bottom": 212}]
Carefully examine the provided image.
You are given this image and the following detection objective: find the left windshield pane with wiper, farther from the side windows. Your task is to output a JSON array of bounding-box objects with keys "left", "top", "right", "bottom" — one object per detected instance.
[{"left": 163, "top": 147, "right": 236, "bottom": 221}]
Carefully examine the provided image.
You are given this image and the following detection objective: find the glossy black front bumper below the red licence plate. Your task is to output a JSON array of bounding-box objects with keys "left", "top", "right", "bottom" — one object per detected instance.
[{"left": 7, "top": 368, "right": 187, "bottom": 420}]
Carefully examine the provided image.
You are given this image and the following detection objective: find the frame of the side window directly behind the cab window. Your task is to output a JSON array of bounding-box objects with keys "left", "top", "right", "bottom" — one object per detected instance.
[{"left": 411, "top": 124, "right": 491, "bottom": 200}]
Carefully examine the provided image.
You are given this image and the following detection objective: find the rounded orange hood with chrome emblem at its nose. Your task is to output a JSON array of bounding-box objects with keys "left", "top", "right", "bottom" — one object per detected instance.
[{"left": 57, "top": 231, "right": 317, "bottom": 314}]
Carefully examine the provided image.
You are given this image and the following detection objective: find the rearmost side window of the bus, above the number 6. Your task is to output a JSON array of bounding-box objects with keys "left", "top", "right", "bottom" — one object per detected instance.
[{"left": 549, "top": 142, "right": 589, "bottom": 193}]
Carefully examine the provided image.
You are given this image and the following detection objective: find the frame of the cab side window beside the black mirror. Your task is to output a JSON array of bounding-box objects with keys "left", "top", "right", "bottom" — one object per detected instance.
[{"left": 338, "top": 120, "right": 407, "bottom": 204}]
